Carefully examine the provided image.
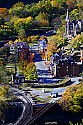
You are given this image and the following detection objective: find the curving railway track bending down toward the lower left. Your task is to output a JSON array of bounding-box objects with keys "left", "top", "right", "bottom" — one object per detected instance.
[{"left": 10, "top": 88, "right": 33, "bottom": 125}]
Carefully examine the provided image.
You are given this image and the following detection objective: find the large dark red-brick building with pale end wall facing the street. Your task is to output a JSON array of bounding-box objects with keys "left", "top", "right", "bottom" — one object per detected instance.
[{"left": 51, "top": 54, "right": 80, "bottom": 77}]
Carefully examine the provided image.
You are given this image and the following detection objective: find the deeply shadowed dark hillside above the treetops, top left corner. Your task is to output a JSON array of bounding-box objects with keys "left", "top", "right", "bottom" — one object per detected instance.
[{"left": 0, "top": 0, "right": 39, "bottom": 8}]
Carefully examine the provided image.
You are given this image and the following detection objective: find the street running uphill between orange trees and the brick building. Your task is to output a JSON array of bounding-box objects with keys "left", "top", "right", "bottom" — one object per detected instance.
[{"left": 32, "top": 44, "right": 61, "bottom": 84}]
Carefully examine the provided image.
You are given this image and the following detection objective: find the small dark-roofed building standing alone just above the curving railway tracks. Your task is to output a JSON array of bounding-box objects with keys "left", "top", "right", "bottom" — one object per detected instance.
[{"left": 13, "top": 73, "right": 25, "bottom": 84}]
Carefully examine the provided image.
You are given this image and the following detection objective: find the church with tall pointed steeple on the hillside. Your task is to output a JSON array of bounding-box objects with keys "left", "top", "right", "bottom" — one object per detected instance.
[{"left": 63, "top": 9, "right": 83, "bottom": 40}]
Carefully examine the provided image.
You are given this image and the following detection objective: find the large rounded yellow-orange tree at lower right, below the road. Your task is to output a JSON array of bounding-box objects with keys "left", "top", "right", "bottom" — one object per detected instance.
[{"left": 59, "top": 83, "right": 83, "bottom": 113}]
